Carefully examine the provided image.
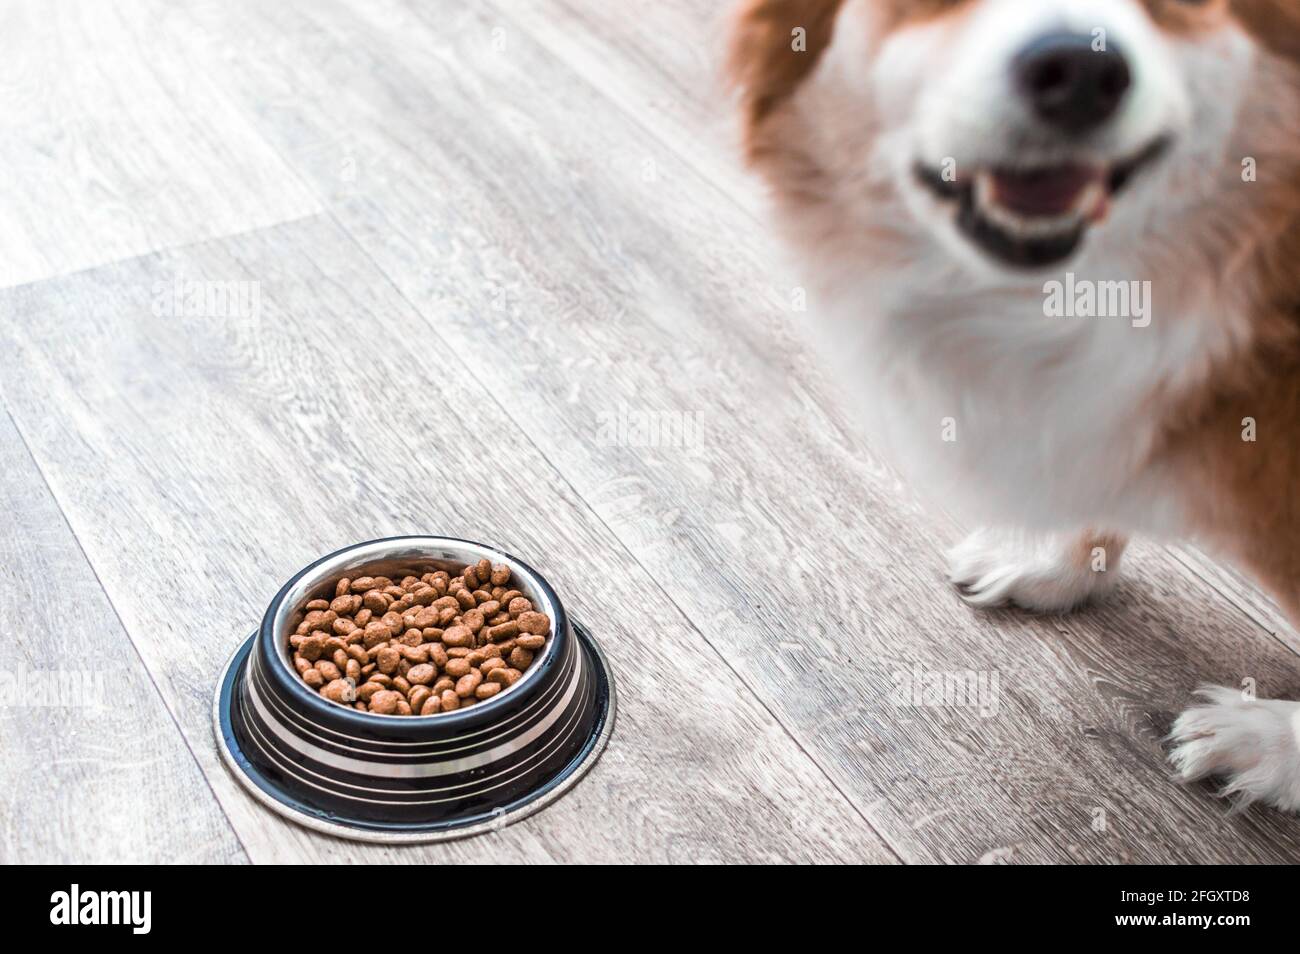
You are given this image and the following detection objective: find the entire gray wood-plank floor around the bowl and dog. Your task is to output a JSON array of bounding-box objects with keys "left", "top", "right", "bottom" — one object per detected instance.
[{"left": 0, "top": 0, "right": 1300, "bottom": 863}]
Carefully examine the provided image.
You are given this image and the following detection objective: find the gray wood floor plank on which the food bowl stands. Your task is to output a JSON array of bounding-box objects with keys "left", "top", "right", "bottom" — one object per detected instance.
[{"left": 0, "top": 218, "right": 892, "bottom": 863}]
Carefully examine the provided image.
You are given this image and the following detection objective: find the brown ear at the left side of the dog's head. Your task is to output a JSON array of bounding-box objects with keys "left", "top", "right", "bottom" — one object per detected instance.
[{"left": 728, "top": 0, "right": 844, "bottom": 155}]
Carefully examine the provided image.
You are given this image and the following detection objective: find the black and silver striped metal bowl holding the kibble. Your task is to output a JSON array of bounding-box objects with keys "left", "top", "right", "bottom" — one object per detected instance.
[{"left": 213, "top": 537, "right": 614, "bottom": 842}]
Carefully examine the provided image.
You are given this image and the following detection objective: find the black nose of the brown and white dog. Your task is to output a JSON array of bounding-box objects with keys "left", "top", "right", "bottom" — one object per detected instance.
[{"left": 1015, "top": 32, "right": 1132, "bottom": 134}]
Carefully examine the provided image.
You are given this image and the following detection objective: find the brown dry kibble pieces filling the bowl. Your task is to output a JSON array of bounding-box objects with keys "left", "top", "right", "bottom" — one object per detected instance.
[{"left": 289, "top": 560, "right": 551, "bottom": 715}]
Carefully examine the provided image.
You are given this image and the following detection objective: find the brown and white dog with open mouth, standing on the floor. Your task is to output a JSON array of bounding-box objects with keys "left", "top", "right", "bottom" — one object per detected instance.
[{"left": 732, "top": 0, "right": 1300, "bottom": 811}]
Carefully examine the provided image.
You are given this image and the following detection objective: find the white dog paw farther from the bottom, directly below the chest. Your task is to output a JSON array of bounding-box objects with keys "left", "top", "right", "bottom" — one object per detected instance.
[{"left": 948, "top": 529, "right": 1119, "bottom": 612}]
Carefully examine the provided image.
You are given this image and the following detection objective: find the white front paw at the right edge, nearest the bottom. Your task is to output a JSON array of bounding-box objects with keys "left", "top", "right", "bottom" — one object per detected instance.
[{"left": 1169, "top": 686, "right": 1300, "bottom": 811}]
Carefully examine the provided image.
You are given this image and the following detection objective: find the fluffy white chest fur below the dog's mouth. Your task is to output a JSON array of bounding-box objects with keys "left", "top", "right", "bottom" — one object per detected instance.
[{"left": 800, "top": 254, "right": 1230, "bottom": 533}]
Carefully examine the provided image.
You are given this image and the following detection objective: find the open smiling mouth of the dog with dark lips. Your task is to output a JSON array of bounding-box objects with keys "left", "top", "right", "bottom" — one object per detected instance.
[{"left": 915, "top": 136, "right": 1169, "bottom": 268}]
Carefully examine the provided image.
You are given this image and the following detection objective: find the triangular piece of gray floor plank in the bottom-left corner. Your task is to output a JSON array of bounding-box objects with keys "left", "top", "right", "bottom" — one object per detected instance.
[{"left": 0, "top": 409, "right": 247, "bottom": 864}]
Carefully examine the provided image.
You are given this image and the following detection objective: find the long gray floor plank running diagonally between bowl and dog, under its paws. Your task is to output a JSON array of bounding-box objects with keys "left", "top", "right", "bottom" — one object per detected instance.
[{"left": 175, "top": 3, "right": 1300, "bottom": 862}]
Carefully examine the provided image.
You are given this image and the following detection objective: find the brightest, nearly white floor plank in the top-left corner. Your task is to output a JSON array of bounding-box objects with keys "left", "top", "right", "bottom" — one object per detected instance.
[{"left": 0, "top": 0, "right": 320, "bottom": 286}]
